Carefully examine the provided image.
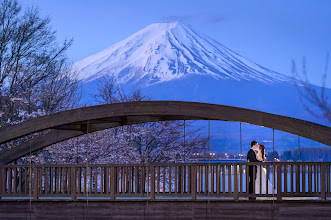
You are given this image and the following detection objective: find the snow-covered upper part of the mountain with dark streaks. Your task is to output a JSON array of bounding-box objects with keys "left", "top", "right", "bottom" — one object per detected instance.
[{"left": 74, "top": 22, "right": 289, "bottom": 87}]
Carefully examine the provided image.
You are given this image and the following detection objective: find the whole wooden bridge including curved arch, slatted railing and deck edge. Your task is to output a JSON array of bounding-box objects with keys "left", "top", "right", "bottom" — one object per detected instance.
[{"left": 0, "top": 101, "right": 331, "bottom": 219}]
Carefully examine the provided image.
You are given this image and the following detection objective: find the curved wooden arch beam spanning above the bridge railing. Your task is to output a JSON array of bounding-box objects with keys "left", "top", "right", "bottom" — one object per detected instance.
[{"left": 0, "top": 101, "right": 331, "bottom": 164}]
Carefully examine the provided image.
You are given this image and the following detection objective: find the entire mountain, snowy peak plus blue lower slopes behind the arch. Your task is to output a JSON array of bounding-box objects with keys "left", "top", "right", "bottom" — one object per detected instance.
[{"left": 74, "top": 22, "right": 331, "bottom": 153}]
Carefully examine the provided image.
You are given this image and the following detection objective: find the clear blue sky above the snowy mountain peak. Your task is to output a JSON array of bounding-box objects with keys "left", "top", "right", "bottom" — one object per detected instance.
[{"left": 24, "top": 0, "right": 331, "bottom": 87}]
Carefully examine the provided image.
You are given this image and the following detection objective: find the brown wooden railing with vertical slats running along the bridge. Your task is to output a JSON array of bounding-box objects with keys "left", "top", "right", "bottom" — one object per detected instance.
[{"left": 0, "top": 162, "right": 331, "bottom": 200}]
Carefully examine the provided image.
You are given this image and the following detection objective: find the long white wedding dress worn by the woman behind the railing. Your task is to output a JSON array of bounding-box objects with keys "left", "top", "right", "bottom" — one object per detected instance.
[{"left": 255, "top": 157, "right": 276, "bottom": 194}]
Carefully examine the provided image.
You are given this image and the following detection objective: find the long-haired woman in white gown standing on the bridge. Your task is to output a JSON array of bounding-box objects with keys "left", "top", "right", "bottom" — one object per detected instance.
[{"left": 255, "top": 145, "right": 275, "bottom": 194}]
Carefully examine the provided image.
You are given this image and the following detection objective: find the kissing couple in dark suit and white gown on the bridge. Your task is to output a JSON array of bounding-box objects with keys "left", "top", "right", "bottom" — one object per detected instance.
[{"left": 247, "top": 141, "right": 274, "bottom": 200}]
